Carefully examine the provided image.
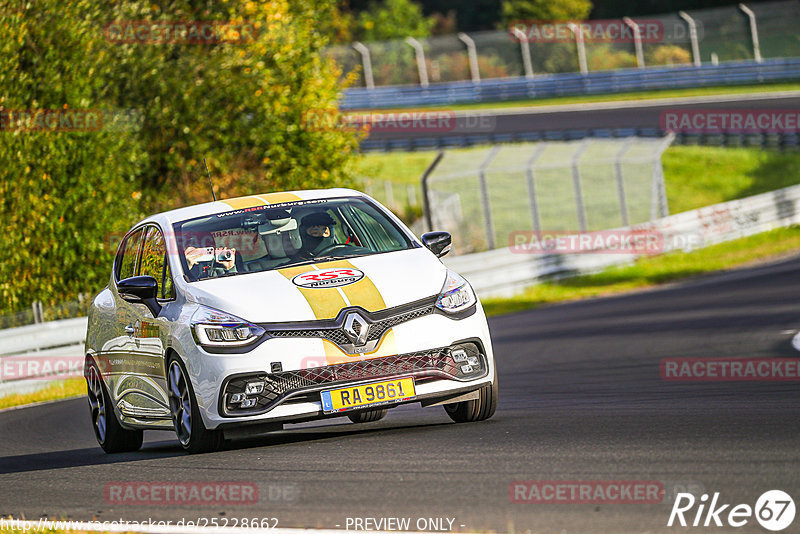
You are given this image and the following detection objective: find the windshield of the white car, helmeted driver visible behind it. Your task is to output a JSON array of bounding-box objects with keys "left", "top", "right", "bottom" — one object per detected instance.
[{"left": 174, "top": 197, "right": 415, "bottom": 282}]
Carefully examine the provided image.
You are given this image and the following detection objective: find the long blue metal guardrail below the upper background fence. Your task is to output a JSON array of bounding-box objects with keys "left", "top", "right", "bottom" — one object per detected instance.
[{"left": 340, "top": 58, "right": 800, "bottom": 110}]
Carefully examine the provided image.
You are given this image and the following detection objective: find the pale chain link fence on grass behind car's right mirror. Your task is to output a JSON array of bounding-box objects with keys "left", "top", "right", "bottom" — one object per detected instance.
[{"left": 422, "top": 135, "right": 673, "bottom": 254}]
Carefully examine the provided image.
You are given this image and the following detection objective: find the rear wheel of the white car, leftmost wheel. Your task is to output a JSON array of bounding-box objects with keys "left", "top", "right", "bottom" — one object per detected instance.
[{"left": 86, "top": 360, "right": 144, "bottom": 454}]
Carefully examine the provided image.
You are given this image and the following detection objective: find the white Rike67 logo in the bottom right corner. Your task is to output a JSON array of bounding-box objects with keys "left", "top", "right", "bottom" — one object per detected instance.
[{"left": 667, "top": 490, "right": 795, "bottom": 532}]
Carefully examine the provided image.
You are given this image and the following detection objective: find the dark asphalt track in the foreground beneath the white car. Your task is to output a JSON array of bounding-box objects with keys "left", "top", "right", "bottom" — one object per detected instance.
[{"left": 0, "top": 256, "right": 800, "bottom": 533}]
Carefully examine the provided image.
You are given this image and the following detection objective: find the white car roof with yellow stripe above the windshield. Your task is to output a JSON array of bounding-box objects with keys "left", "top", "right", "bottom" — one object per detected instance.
[{"left": 136, "top": 188, "right": 366, "bottom": 226}]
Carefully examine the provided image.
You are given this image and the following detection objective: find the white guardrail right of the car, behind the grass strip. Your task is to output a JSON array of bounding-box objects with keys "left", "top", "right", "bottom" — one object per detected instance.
[{"left": 444, "top": 185, "right": 800, "bottom": 298}]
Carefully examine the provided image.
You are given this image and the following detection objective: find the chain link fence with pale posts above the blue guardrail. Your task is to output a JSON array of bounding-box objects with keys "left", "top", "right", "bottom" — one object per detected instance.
[{"left": 326, "top": 0, "right": 800, "bottom": 87}]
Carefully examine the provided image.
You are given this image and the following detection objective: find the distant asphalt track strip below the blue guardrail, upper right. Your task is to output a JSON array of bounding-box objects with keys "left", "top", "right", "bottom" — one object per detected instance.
[{"left": 369, "top": 91, "right": 800, "bottom": 140}]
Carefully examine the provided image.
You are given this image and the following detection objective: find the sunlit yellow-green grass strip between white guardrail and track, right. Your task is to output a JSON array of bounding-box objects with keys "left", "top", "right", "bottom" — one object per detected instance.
[{"left": 482, "top": 226, "right": 800, "bottom": 315}]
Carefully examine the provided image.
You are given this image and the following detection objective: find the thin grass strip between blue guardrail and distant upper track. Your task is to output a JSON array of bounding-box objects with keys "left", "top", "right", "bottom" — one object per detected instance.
[{"left": 366, "top": 82, "right": 800, "bottom": 113}]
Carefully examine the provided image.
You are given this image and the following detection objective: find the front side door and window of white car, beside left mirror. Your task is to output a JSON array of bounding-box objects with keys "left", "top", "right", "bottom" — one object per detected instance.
[{"left": 120, "top": 225, "right": 175, "bottom": 419}]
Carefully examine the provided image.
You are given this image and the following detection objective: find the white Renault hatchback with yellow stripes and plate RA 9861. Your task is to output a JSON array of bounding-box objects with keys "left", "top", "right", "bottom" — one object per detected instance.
[{"left": 85, "top": 189, "right": 497, "bottom": 453}]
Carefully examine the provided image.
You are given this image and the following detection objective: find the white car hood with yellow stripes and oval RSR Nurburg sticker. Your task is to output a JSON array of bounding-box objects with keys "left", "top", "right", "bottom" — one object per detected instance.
[{"left": 186, "top": 248, "right": 447, "bottom": 323}]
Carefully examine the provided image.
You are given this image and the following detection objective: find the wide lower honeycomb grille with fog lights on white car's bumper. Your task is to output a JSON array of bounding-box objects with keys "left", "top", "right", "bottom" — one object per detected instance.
[{"left": 221, "top": 343, "right": 487, "bottom": 416}]
